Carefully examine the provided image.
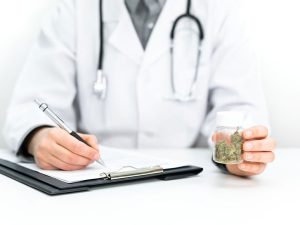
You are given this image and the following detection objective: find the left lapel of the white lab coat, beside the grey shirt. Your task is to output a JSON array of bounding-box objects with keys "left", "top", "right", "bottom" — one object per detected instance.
[{"left": 107, "top": 0, "right": 144, "bottom": 63}]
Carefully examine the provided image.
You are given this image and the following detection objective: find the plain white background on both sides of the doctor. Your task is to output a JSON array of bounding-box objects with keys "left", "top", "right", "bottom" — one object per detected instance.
[{"left": 0, "top": 0, "right": 300, "bottom": 147}]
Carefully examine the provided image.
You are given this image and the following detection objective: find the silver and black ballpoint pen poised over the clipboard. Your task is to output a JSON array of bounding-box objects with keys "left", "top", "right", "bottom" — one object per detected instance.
[{"left": 34, "top": 99, "right": 105, "bottom": 167}]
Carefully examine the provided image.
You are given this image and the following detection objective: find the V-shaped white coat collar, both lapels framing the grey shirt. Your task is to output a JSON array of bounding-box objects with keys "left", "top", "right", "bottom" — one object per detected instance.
[{"left": 104, "top": 0, "right": 186, "bottom": 67}]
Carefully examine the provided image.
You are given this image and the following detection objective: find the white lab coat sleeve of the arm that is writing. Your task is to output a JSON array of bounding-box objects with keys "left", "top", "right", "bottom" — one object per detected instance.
[{"left": 4, "top": 0, "right": 76, "bottom": 152}]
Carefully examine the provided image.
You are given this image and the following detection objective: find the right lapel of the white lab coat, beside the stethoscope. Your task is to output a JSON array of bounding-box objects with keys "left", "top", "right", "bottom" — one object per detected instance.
[{"left": 143, "top": 0, "right": 185, "bottom": 67}]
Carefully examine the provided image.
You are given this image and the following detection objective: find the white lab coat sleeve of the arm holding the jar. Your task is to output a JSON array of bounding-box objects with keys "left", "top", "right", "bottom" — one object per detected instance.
[{"left": 202, "top": 0, "right": 269, "bottom": 146}]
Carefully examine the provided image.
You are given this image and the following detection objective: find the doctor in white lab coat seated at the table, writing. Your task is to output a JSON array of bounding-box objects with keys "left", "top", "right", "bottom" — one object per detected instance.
[{"left": 4, "top": 0, "right": 275, "bottom": 176}]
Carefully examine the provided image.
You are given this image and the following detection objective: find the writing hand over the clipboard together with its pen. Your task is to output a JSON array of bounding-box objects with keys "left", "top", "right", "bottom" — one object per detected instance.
[{"left": 28, "top": 99, "right": 104, "bottom": 170}]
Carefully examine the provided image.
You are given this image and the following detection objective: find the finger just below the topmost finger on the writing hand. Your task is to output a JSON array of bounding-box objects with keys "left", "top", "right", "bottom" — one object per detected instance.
[{"left": 51, "top": 144, "right": 93, "bottom": 166}]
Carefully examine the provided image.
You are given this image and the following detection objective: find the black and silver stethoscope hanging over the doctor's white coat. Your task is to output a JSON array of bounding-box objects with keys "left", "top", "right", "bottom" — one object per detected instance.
[{"left": 94, "top": 0, "right": 204, "bottom": 102}]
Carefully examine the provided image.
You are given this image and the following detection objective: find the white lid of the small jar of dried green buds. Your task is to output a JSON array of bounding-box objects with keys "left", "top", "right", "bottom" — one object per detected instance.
[{"left": 216, "top": 111, "right": 245, "bottom": 127}]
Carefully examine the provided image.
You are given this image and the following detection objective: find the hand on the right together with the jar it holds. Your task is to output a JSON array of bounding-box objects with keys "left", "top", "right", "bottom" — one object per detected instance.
[{"left": 213, "top": 112, "right": 276, "bottom": 176}]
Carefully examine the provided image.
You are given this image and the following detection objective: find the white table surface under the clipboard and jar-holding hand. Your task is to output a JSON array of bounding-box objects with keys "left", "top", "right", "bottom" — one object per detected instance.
[{"left": 0, "top": 149, "right": 300, "bottom": 225}]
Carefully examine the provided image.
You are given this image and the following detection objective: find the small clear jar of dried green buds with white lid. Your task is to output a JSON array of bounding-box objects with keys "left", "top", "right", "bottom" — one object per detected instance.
[{"left": 213, "top": 111, "right": 244, "bottom": 165}]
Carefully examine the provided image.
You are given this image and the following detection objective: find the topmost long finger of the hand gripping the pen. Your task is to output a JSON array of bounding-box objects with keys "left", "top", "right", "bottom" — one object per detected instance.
[{"left": 49, "top": 129, "right": 99, "bottom": 160}]
